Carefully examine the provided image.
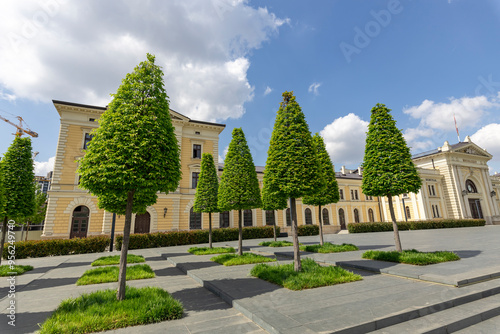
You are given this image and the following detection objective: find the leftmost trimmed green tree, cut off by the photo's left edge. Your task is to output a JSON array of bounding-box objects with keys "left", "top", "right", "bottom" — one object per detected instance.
[{"left": 0, "top": 137, "right": 35, "bottom": 263}]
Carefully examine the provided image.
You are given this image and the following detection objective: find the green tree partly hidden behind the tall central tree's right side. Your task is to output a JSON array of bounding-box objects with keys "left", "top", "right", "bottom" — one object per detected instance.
[{"left": 302, "top": 133, "right": 339, "bottom": 245}]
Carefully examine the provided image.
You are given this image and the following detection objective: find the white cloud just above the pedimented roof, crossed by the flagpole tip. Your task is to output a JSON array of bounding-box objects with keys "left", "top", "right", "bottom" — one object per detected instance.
[{"left": 403, "top": 96, "right": 499, "bottom": 131}]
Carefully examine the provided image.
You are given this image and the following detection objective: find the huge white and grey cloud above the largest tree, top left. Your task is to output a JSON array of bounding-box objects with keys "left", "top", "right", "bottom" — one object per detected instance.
[{"left": 0, "top": 0, "right": 288, "bottom": 120}]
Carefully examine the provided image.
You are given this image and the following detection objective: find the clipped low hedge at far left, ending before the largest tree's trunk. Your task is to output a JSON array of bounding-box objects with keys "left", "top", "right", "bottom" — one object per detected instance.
[{"left": 3, "top": 236, "right": 110, "bottom": 259}]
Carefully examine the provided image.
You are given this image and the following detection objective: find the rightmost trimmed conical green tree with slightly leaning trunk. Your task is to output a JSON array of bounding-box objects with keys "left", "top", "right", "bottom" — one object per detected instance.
[{"left": 361, "top": 103, "right": 422, "bottom": 252}]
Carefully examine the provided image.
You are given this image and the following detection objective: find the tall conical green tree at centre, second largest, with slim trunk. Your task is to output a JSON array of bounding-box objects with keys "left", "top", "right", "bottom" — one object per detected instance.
[{"left": 264, "top": 92, "right": 323, "bottom": 271}]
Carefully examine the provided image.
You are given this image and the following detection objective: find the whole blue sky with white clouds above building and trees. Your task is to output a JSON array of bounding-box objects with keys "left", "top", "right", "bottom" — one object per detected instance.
[{"left": 0, "top": 0, "right": 500, "bottom": 175}]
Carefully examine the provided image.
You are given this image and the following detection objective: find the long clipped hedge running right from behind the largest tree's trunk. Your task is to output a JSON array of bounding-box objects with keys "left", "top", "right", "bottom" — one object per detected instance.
[{"left": 116, "top": 226, "right": 280, "bottom": 250}]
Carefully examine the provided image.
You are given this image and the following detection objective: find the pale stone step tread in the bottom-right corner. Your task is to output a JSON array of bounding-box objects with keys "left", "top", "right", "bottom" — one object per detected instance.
[{"left": 370, "top": 294, "right": 500, "bottom": 334}]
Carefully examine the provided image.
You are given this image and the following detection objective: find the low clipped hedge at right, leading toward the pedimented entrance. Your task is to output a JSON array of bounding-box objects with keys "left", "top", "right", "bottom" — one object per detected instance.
[{"left": 347, "top": 219, "right": 486, "bottom": 233}]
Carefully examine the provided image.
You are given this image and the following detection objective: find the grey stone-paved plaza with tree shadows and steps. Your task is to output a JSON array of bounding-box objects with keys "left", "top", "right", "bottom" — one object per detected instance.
[{"left": 0, "top": 226, "right": 500, "bottom": 334}]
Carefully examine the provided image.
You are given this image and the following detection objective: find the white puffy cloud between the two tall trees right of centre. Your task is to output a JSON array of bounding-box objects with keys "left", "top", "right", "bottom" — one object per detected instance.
[{"left": 320, "top": 113, "right": 368, "bottom": 167}]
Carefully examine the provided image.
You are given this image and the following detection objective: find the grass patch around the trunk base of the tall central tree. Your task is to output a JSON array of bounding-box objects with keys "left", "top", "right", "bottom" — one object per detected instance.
[{"left": 250, "top": 259, "right": 362, "bottom": 290}]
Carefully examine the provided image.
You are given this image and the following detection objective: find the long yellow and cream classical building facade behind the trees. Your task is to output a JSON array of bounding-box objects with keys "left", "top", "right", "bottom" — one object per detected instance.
[{"left": 42, "top": 101, "right": 500, "bottom": 238}]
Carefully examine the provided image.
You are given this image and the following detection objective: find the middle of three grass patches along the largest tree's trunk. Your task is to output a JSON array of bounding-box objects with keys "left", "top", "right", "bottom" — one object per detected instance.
[{"left": 76, "top": 264, "right": 155, "bottom": 285}]
